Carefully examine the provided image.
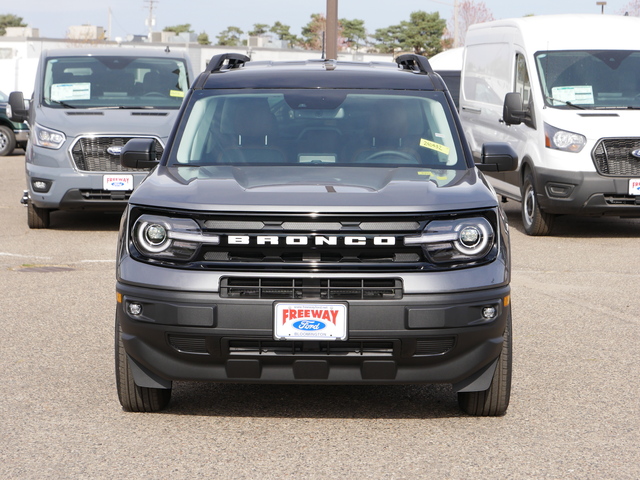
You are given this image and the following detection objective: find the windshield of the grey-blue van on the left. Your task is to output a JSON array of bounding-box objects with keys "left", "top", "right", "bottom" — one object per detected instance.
[{"left": 43, "top": 56, "right": 189, "bottom": 108}]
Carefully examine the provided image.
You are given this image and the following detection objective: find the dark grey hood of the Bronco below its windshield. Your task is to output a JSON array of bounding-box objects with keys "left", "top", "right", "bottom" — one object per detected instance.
[{"left": 130, "top": 166, "right": 497, "bottom": 213}]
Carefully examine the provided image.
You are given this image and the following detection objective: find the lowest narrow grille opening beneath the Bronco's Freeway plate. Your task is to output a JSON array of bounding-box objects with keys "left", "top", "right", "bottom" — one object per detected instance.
[{"left": 228, "top": 340, "right": 394, "bottom": 357}]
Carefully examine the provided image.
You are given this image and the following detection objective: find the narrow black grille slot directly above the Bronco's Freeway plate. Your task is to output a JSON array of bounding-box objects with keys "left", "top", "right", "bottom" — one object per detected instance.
[{"left": 220, "top": 277, "right": 403, "bottom": 300}]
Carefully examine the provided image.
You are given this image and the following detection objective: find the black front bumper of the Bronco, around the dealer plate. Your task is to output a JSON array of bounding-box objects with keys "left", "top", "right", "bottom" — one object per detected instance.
[{"left": 116, "top": 282, "right": 511, "bottom": 391}]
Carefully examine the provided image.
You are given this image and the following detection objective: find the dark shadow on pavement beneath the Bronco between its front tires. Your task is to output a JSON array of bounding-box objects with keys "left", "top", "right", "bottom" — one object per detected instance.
[{"left": 164, "top": 382, "right": 464, "bottom": 419}]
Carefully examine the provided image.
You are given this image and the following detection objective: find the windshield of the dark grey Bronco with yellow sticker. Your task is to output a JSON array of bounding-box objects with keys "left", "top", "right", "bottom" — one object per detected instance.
[{"left": 169, "top": 89, "right": 467, "bottom": 170}]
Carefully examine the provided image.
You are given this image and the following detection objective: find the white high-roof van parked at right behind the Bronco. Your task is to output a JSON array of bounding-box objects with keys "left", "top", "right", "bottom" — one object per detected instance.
[{"left": 460, "top": 15, "right": 640, "bottom": 235}]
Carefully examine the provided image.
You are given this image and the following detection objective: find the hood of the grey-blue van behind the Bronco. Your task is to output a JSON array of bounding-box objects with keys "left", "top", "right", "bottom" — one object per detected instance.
[{"left": 37, "top": 107, "right": 178, "bottom": 140}]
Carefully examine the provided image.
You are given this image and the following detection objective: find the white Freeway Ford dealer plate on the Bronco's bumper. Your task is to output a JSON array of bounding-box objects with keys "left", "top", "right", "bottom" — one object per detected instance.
[{"left": 273, "top": 303, "right": 347, "bottom": 340}]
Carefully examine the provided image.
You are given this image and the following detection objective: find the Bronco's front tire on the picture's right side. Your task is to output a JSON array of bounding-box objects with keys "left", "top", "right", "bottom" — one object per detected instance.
[{"left": 458, "top": 315, "right": 513, "bottom": 417}]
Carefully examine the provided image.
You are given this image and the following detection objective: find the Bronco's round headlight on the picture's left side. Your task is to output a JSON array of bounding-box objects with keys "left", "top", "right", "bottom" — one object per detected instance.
[{"left": 131, "top": 215, "right": 220, "bottom": 261}]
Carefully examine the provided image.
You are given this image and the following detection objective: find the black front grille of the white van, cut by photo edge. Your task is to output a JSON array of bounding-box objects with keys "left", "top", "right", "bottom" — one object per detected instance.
[{"left": 592, "top": 138, "right": 640, "bottom": 177}]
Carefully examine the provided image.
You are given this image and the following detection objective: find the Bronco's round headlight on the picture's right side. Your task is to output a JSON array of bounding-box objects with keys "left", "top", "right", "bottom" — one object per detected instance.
[{"left": 404, "top": 217, "right": 495, "bottom": 263}]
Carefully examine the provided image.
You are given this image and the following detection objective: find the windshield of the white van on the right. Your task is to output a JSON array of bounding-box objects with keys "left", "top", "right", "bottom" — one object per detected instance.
[{"left": 535, "top": 50, "right": 640, "bottom": 109}]
